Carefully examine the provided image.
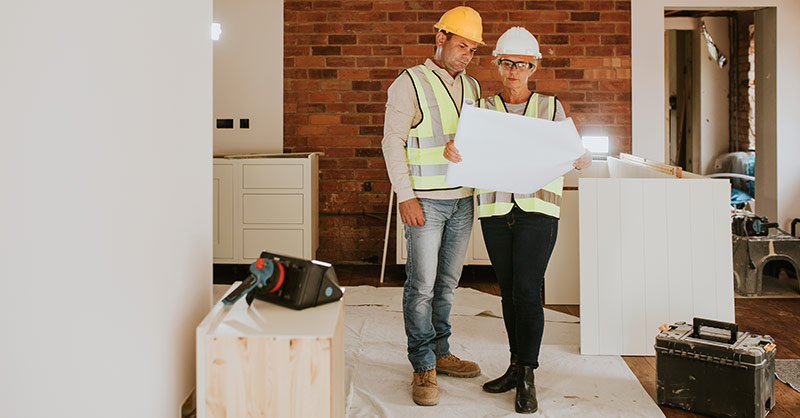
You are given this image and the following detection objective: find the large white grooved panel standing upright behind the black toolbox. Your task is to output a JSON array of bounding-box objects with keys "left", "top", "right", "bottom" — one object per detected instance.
[{"left": 579, "top": 179, "right": 734, "bottom": 355}]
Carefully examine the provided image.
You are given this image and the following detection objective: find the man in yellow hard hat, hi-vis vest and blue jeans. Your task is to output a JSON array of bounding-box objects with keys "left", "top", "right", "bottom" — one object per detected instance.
[{"left": 382, "top": 6, "right": 483, "bottom": 405}]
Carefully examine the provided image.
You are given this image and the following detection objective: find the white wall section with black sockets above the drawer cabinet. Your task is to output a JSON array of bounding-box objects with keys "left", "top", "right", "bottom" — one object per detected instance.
[{"left": 214, "top": 0, "right": 283, "bottom": 155}]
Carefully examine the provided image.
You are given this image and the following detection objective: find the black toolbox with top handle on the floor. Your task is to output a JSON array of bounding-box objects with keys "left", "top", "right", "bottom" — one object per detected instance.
[{"left": 655, "top": 318, "right": 775, "bottom": 418}]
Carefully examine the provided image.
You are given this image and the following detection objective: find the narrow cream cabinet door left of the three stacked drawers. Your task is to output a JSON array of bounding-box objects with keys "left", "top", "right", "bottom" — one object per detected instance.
[{"left": 214, "top": 163, "right": 233, "bottom": 261}]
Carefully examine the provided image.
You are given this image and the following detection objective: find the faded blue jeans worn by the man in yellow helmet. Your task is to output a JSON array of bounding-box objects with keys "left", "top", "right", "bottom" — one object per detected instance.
[{"left": 403, "top": 196, "right": 473, "bottom": 372}]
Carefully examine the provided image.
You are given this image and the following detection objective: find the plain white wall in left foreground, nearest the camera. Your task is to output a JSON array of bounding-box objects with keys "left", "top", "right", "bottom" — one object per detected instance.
[{"left": 0, "top": 0, "right": 212, "bottom": 418}]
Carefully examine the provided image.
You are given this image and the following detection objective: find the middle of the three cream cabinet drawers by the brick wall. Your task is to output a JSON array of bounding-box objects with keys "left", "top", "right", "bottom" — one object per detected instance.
[{"left": 242, "top": 194, "right": 303, "bottom": 224}]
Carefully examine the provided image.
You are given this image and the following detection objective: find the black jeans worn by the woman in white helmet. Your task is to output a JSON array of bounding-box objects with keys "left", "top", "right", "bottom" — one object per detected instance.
[{"left": 481, "top": 205, "right": 558, "bottom": 369}]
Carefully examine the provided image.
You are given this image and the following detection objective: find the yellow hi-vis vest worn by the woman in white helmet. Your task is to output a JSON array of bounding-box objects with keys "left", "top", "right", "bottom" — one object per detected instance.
[{"left": 475, "top": 93, "right": 564, "bottom": 218}]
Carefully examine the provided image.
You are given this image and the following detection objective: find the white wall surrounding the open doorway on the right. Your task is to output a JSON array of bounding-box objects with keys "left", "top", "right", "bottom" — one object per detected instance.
[{"left": 631, "top": 0, "right": 800, "bottom": 229}]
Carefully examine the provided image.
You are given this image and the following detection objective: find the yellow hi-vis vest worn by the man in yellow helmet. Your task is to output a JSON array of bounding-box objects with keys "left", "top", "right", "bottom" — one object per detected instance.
[{"left": 404, "top": 65, "right": 481, "bottom": 190}]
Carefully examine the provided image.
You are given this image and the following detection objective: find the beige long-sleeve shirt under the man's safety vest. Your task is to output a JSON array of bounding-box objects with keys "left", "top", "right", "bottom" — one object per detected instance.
[{"left": 381, "top": 59, "right": 472, "bottom": 202}]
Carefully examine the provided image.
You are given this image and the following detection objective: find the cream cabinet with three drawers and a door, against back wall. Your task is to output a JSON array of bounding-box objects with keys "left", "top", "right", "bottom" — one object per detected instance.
[{"left": 214, "top": 153, "right": 319, "bottom": 264}]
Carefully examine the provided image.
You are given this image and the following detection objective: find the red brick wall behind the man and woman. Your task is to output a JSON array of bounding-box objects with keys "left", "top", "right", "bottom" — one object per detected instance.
[{"left": 284, "top": 0, "right": 631, "bottom": 263}]
